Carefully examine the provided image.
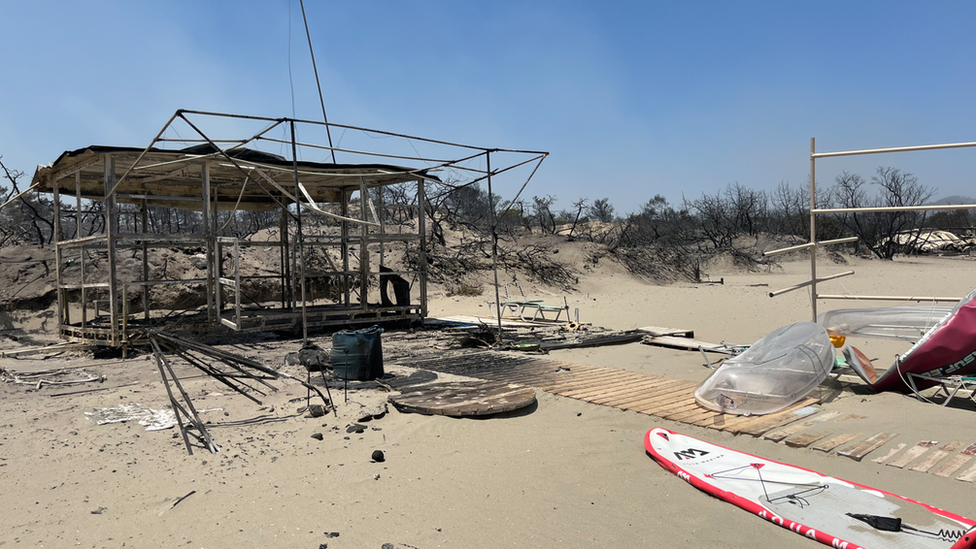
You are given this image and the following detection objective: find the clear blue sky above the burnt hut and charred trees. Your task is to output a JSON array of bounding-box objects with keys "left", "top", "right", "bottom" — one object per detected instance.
[{"left": 0, "top": 0, "right": 976, "bottom": 214}]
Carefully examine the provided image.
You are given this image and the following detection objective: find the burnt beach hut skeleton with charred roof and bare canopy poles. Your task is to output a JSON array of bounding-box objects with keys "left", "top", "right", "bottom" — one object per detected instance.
[{"left": 31, "top": 110, "right": 548, "bottom": 347}]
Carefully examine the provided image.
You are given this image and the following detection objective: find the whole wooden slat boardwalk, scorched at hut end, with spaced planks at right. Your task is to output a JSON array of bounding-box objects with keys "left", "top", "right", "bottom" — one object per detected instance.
[{"left": 396, "top": 351, "right": 976, "bottom": 482}]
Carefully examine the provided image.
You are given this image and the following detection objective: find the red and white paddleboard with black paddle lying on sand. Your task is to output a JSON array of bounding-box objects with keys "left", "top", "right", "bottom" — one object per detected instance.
[{"left": 644, "top": 428, "right": 976, "bottom": 549}]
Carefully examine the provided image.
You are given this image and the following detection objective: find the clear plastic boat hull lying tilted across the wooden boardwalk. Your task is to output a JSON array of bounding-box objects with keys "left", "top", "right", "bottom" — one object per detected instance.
[{"left": 695, "top": 322, "right": 834, "bottom": 415}]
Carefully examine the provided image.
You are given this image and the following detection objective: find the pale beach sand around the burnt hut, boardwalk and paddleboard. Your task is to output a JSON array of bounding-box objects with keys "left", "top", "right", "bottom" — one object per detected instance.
[{"left": 0, "top": 258, "right": 976, "bottom": 549}]
